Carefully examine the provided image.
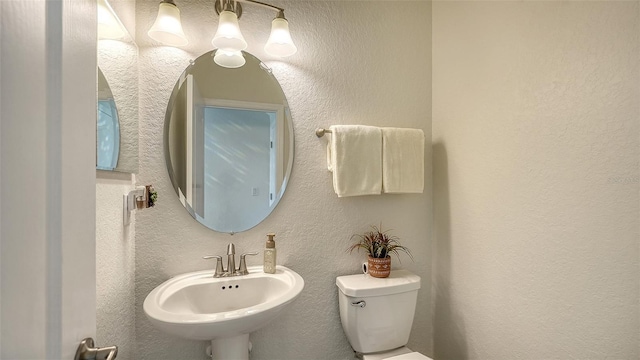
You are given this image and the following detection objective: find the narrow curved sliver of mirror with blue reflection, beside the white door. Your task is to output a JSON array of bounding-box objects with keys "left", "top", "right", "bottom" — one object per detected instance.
[{"left": 96, "top": 69, "right": 120, "bottom": 170}]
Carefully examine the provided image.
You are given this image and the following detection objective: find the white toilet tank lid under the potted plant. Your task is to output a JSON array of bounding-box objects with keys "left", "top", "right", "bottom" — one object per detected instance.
[{"left": 336, "top": 270, "right": 420, "bottom": 297}]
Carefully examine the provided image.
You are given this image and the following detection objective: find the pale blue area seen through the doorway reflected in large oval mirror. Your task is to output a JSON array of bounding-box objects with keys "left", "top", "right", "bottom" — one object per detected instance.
[{"left": 202, "top": 107, "right": 275, "bottom": 232}]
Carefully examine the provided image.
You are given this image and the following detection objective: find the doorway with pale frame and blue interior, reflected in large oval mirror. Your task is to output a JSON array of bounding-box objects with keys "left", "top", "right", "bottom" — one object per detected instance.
[{"left": 193, "top": 100, "right": 284, "bottom": 232}]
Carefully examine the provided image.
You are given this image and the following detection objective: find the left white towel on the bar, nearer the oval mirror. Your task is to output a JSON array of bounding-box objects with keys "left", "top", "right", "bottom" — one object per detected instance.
[{"left": 327, "top": 125, "right": 382, "bottom": 197}]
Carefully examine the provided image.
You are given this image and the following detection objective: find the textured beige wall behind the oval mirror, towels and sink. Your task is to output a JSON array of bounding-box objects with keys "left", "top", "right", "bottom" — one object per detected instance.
[{"left": 136, "top": 0, "right": 432, "bottom": 360}]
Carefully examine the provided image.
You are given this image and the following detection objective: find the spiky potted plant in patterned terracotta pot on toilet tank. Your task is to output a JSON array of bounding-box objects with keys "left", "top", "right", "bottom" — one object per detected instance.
[{"left": 348, "top": 225, "right": 413, "bottom": 278}]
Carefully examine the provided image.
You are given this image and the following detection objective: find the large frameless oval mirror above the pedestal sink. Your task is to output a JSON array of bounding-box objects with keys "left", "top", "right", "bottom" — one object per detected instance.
[{"left": 164, "top": 51, "right": 293, "bottom": 233}]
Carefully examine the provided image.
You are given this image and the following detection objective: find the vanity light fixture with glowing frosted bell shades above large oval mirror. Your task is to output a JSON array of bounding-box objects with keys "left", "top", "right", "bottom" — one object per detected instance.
[{"left": 149, "top": 0, "right": 298, "bottom": 67}]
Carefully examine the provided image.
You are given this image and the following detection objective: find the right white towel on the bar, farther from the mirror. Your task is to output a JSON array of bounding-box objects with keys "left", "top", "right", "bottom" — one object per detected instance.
[{"left": 382, "top": 128, "right": 424, "bottom": 193}]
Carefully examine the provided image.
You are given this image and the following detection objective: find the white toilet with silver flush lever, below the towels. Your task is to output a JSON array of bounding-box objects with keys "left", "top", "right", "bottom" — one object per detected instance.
[{"left": 336, "top": 270, "right": 431, "bottom": 360}]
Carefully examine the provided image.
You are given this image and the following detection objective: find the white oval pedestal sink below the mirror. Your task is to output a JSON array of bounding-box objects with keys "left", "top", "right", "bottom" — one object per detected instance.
[{"left": 143, "top": 266, "right": 304, "bottom": 360}]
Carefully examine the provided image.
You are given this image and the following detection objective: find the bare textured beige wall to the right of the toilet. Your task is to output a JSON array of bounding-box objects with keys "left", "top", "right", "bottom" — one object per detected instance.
[{"left": 432, "top": 1, "right": 640, "bottom": 359}]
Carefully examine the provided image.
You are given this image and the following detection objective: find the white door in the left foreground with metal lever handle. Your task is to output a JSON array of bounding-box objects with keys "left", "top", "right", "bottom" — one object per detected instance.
[{"left": 0, "top": 0, "right": 97, "bottom": 359}]
